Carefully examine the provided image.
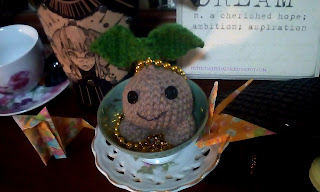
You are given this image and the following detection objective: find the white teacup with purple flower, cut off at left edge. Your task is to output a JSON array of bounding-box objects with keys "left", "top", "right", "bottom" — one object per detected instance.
[{"left": 0, "top": 25, "right": 44, "bottom": 94}]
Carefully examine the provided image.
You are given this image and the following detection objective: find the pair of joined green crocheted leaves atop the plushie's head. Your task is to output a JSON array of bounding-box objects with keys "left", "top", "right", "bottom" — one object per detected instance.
[{"left": 91, "top": 23, "right": 204, "bottom": 68}]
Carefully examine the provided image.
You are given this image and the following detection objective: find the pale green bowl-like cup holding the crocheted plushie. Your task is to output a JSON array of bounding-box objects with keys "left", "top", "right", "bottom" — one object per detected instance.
[{"left": 98, "top": 79, "right": 208, "bottom": 164}]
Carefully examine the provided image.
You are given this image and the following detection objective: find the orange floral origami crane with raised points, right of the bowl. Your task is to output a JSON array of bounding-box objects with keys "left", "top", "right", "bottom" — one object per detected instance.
[{"left": 196, "top": 80, "right": 275, "bottom": 152}]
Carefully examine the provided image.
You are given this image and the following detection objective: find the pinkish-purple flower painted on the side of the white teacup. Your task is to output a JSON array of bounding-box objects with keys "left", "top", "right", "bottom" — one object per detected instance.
[{"left": 0, "top": 71, "right": 30, "bottom": 94}]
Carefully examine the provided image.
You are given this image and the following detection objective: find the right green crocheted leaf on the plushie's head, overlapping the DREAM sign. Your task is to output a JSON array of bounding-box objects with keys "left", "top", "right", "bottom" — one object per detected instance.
[{"left": 148, "top": 23, "right": 204, "bottom": 60}]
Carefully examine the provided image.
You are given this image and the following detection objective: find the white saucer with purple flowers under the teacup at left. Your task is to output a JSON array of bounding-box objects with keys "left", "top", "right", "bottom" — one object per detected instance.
[{"left": 0, "top": 80, "right": 70, "bottom": 116}]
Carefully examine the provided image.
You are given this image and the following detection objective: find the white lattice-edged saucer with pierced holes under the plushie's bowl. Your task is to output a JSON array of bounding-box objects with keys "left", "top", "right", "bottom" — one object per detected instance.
[{"left": 91, "top": 127, "right": 221, "bottom": 191}]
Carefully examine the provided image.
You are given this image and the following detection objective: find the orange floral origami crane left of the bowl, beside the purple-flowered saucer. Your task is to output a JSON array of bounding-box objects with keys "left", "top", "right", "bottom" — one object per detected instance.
[{"left": 13, "top": 108, "right": 94, "bottom": 165}]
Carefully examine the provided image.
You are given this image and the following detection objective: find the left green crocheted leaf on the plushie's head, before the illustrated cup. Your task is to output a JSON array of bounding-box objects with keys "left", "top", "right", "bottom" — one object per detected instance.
[{"left": 91, "top": 25, "right": 141, "bottom": 68}]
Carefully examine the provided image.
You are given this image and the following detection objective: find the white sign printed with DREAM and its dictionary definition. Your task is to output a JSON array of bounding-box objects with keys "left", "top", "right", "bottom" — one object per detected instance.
[{"left": 176, "top": 0, "right": 320, "bottom": 79}]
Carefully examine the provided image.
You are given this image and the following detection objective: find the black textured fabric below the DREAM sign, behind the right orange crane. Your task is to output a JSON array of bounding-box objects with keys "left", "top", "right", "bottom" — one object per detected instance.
[{"left": 217, "top": 78, "right": 320, "bottom": 137}]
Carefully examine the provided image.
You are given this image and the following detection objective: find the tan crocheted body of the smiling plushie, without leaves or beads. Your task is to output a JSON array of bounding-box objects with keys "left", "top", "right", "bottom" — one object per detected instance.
[{"left": 119, "top": 65, "right": 196, "bottom": 145}]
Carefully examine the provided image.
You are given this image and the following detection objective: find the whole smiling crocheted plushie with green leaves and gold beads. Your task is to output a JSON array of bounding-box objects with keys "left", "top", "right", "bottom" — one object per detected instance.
[{"left": 92, "top": 24, "right": 204, "bottom": 151}]
